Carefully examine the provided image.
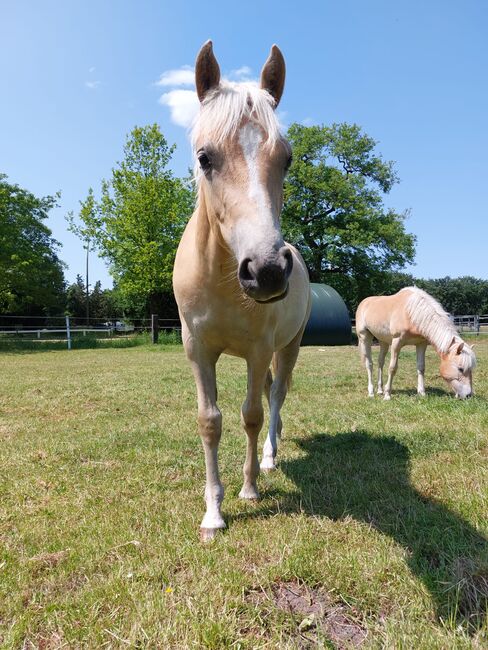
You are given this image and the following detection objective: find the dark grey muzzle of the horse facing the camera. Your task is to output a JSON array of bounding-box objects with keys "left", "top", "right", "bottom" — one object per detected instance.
[{"left": 238, "top": 246, "right": 293, "bottom": 303}]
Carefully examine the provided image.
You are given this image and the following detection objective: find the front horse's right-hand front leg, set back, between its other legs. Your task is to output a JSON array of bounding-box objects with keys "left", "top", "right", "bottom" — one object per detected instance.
[{"left": 239, "top": 354, "right": 271, "bottom": 499}]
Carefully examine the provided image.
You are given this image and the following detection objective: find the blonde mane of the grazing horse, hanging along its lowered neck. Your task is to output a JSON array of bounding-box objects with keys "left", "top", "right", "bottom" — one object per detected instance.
[{"left": 402, "top": 287, "right": 476, "bottom": 370}]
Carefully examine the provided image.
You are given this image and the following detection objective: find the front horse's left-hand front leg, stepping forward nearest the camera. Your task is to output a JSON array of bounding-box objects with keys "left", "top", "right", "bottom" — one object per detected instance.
[{"left": 184, "top": 339, "right": 225, "bottom": 541}]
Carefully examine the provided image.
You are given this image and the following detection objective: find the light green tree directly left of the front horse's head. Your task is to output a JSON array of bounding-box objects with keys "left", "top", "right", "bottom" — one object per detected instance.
[{"left": 72, "top": 124, "right": 194, "bottom": 313}]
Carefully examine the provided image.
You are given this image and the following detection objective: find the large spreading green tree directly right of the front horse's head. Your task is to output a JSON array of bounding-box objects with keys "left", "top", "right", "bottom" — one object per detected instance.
[{"left": 282, "top": 124, "right": 415, "bottom": 311}]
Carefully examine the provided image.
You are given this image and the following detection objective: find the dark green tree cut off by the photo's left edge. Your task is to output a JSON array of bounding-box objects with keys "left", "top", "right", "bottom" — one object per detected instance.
[{"left": 0, "top": 174, "right": 65, "bottom": 314}]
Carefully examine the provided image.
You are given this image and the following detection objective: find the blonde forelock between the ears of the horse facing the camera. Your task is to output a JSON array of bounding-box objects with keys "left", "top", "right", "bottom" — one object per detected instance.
[{"left": 191, "top": 81, "right": 283, "bottom": 178}]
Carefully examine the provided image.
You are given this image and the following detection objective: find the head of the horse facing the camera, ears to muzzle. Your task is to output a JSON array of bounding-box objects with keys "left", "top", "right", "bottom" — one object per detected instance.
[{"left": 192, "top": 41, "right": 293, "bottom": 303}]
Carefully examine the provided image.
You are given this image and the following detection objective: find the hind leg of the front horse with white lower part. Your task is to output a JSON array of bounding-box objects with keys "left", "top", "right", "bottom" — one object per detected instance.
[{"left": 261, "top": 332, "right": 302, "bottom": 471}]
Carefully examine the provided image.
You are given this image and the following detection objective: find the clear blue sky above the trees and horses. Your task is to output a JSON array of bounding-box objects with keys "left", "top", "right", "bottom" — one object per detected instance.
[{"left": 0, "top": 0, "right": 488, "bottom": 287}]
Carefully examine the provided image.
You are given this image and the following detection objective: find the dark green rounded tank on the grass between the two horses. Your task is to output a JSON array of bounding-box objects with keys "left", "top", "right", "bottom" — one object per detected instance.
[{"left": 301, "top": 282, "right": 352, "bottom": 345}]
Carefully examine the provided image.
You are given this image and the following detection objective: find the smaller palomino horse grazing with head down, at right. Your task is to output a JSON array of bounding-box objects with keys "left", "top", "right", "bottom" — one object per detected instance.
[{"left": 356, "top": 287, "right": 476, "bottom": 399}]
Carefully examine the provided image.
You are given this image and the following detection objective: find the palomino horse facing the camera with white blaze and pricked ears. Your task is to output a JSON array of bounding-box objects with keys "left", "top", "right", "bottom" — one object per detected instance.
[{"left": 173, "top": 41, "right": 310, "bottom": 540}]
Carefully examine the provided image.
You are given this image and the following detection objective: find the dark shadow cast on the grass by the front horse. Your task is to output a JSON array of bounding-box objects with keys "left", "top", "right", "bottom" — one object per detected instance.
[{"left": 266, "top": 431, "right": 488, "bottom": 632}]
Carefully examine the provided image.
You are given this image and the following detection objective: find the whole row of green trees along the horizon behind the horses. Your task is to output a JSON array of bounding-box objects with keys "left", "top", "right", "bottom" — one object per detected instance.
[{"left": 0, "top": 124, "right": 488, "bottom": 320}]
